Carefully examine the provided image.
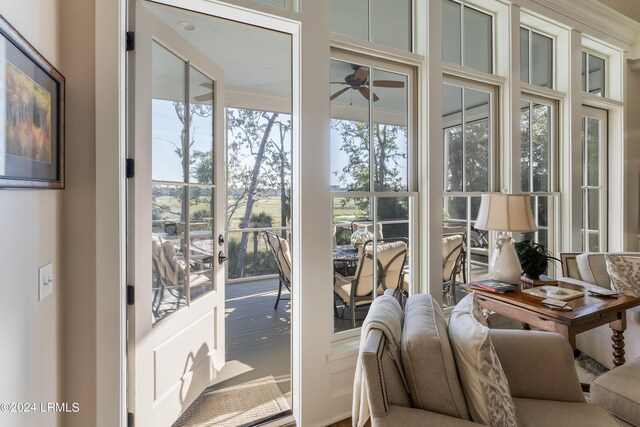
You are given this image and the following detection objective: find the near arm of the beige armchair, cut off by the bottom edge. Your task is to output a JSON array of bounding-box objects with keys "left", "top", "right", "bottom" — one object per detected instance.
[{"left": 371, "top": 405, "right": 483, "bottom": 427}]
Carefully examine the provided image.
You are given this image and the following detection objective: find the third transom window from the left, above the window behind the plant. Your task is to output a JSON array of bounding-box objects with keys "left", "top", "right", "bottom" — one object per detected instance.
[{"left": 520, "top": 27, "right": 553, "bottom": 89}]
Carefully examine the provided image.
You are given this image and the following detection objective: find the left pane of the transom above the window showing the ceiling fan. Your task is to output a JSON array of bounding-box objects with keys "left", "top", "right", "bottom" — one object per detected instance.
[{"left": 331, "top": 0, "right": 369, "bottom": 40}]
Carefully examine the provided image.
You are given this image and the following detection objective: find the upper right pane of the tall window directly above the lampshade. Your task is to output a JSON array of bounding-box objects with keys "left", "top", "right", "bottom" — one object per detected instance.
[{"left": 464, "top": 88, "right": 491, "bottom": 191}]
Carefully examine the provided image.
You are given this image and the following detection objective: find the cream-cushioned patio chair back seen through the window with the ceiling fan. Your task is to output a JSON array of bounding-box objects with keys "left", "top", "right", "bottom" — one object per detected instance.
[{"left": 355, "top": 239, "right": 407, "bottom": 296}]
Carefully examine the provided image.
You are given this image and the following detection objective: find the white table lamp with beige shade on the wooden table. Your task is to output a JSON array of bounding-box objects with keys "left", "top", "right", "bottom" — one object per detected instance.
[{"left": 475, "top": 194, "right": 538, "bottom": 284}]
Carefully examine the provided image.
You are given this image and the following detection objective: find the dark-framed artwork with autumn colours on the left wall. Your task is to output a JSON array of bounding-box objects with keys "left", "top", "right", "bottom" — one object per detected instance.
[{"left": 0, "top": 16, "right": 65, "bottom": 189}]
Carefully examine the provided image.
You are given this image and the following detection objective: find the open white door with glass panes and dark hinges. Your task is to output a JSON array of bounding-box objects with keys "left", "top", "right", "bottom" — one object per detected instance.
[{"left": 127, "top": 1, "right": 225, "bottom": 427}]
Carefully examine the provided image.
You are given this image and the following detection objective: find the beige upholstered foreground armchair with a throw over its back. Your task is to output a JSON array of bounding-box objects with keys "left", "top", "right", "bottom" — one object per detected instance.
[{"left": 353, "top": 295, "right": 619, "bottom": 427}]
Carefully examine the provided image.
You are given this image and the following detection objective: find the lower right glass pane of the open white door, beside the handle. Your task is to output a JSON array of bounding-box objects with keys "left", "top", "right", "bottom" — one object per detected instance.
[{"left": 189, "top": 187, "right": 217, "bottom": 300}]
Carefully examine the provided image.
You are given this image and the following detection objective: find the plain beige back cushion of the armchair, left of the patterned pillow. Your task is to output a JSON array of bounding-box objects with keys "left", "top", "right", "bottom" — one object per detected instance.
[{"left": 402, "top": 294, "right": 469, "bottom": 420}]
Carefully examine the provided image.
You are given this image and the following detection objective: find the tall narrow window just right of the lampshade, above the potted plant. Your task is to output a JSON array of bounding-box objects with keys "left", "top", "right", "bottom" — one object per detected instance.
[{"left": 520, "top": 95, "right": 558, "bottom": 252}]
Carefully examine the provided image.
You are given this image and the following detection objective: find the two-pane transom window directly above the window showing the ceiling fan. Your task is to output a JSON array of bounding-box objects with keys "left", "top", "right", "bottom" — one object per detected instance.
[{"left": 331, "top": 0, "right": 413, "bottom": 51}]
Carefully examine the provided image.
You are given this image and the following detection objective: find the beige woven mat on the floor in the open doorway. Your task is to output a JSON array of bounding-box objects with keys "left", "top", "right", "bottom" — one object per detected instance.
[{"left": 173, "top": 376, "right": 290, "bottom": 427}]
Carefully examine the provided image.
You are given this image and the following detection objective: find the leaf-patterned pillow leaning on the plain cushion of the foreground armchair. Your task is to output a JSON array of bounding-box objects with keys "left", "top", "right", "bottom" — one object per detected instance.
[{"left": 449, "top": 294, "right": 517, "bottom": 427}]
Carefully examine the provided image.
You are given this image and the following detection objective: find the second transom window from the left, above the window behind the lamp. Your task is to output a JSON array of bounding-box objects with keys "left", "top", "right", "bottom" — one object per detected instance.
[{"left": 442, "top": 0, "right": 493, "bottom": 73}]
